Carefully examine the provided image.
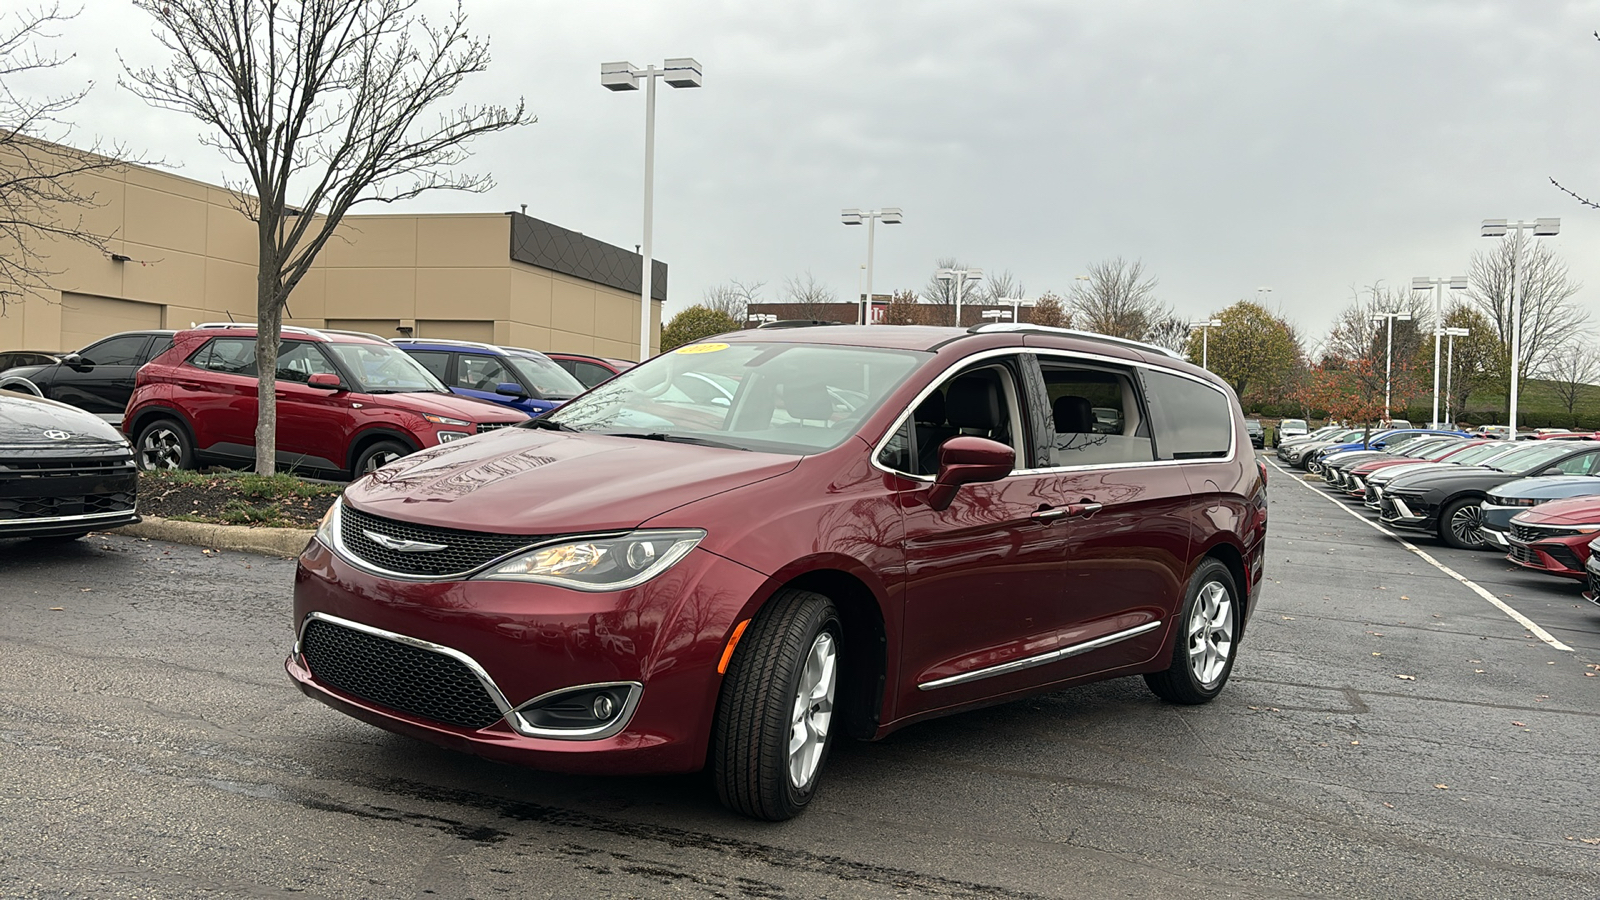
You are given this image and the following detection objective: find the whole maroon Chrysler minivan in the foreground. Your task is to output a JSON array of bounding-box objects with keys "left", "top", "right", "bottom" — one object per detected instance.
[{"left": 286, "top": 325, "right": 1267, "bottom": 820}]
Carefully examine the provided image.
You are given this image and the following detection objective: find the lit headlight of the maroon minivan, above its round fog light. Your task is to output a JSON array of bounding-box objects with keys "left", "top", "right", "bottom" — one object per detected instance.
[{"left": 482, "top": 528, "right": 706, "bottom": 591}]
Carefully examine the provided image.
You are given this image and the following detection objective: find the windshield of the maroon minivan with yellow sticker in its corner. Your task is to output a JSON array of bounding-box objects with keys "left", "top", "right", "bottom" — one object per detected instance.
[{"left": 544, "top": 343, "right": 928, "bottom": 453}]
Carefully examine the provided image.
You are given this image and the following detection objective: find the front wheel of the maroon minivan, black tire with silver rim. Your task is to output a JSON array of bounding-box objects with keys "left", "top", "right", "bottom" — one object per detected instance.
[{"left": 710, "top": 591, "right": 843, "bottom": 822}]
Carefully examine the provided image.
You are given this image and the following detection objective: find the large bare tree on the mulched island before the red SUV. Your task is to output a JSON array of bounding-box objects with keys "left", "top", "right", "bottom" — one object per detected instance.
[{"left": 125, "top": 0, "right": 533, "bottom": 474}]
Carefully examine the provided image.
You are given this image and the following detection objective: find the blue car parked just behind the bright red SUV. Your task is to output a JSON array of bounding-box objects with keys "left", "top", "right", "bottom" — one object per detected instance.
[{"left": 392, "top": 338, "right": 586, "bottom": 416}]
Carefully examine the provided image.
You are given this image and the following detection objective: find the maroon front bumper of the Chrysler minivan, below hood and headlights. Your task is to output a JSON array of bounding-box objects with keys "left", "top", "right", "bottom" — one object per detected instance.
[{"left": 285, "top": 531, "right": 766, "bottom": 773}]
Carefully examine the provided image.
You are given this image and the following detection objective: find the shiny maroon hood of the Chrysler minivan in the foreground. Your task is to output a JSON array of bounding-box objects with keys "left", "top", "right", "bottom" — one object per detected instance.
[{"left": 344, "top": 428, "right": 800, "bottom": 535}]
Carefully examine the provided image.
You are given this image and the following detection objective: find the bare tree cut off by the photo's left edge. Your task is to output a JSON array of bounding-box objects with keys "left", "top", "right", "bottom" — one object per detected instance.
[{"left": 0, "top": 5, "right": 139, "bottom": 315}]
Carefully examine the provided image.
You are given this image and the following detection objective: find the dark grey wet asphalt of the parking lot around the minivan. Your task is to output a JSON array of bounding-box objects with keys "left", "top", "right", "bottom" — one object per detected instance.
[{"left": 0, "top": 458, "right": 1600, "bottom": 898}]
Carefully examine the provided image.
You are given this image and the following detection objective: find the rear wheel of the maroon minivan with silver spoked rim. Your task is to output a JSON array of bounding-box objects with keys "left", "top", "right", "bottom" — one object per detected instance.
[{"left": 1144, "top": 559, "right": 1245, "bottom": 706}]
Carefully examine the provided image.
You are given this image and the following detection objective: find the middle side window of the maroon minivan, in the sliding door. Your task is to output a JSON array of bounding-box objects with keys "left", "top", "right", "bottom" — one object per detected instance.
[{"left": 1038, "top": 359, "right": 1155, "bottom": 466}]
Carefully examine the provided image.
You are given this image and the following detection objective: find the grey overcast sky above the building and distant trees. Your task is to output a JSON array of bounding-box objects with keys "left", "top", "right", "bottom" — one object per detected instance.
[{"left": 37, "top": 0, "right": 1600, "bottom": 340}]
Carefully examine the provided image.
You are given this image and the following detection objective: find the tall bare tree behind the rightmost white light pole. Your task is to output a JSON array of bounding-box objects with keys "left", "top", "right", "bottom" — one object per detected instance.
[{"left": 1467, "top": 231, "right": 1589, "bottom": 406}]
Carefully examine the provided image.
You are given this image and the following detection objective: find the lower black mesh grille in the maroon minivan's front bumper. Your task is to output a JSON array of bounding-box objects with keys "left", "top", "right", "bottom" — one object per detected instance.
[{"left": 301, "top": 620, "right": 501, "bottom": 729}]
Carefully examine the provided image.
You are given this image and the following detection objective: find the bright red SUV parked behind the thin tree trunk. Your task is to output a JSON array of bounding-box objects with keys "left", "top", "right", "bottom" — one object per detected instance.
[{"left": 122, "top": 325, "right": 528, "bottom": 476}]
